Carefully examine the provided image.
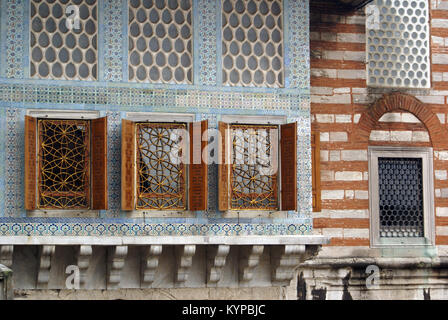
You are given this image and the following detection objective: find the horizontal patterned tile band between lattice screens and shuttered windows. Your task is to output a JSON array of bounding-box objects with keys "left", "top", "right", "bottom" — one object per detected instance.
[{"left": 0, "top": 83, "right": 309, "bottom": 111}]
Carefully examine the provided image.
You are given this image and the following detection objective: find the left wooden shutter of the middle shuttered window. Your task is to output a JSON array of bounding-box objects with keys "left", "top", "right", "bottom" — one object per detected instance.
[{"left": 121, "top": 119, "right": 135, "bottom": 210}]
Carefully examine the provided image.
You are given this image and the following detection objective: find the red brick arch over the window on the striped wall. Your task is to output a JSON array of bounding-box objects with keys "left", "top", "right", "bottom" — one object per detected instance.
[{"left": 353, "top": 92, "right": 448, "bottom": 149}]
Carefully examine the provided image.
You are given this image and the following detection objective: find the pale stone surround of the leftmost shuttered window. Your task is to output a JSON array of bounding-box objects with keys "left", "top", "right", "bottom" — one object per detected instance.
[{"left": 25, "top": 109, "right": 101, "bottom": 217}]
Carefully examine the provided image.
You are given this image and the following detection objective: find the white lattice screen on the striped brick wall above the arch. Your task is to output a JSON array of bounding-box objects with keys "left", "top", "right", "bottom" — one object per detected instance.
[{"left": 366, "top": 0, "right": 430, "bottom": 88}]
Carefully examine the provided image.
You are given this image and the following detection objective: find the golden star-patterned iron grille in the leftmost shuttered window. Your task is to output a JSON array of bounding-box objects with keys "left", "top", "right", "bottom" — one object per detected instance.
[{"left": 38, "top": 119, "right": 90, "bottom": 209}]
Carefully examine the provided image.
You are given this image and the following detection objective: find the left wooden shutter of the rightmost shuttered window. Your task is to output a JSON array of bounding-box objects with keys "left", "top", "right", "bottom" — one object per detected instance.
[{"left": 218, "top": 121, "right": 230, "bottom": 211}]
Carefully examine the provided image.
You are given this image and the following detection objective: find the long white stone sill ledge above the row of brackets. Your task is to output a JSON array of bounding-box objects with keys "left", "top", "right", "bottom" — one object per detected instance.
[{"left": 0, "top": 235, "right": 330, "bottom": 246}]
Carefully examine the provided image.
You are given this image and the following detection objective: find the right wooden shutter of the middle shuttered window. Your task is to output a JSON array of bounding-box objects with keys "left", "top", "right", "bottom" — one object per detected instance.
[{"left": 188, "top": 120, "right": 208, "bottom": 211}]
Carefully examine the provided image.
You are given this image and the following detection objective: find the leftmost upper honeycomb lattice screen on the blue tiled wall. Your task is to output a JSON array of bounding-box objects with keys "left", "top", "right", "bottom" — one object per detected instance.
[{"left": 30, "top": 0, "right": 98, "bottom": 80}]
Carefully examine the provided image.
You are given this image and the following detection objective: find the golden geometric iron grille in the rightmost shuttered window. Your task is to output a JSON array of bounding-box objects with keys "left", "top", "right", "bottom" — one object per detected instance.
[{"left": 230, "top": 124, "right": 278, "bottom": 210}]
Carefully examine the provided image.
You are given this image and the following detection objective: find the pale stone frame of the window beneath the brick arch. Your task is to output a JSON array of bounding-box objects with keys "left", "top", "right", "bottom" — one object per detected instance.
[{"left": 368, "top": 146, "right": 435, "bottom": 248}]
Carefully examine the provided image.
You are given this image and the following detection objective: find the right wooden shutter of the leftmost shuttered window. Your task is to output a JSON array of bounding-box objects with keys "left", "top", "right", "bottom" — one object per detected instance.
[{"left": 91, "top": 117, "right": 107, "bottom": 210}]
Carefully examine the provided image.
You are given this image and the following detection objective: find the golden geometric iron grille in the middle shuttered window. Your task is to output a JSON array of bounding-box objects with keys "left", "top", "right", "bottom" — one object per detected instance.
[{"left": 136, "top": 123, "right": 187, "bottom": 210}]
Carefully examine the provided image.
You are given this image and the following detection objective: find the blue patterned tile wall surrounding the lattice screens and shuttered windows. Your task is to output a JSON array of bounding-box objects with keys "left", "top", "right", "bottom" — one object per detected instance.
[{"left": 0, "top": 0, "right": 312, "bottom": 236}]
